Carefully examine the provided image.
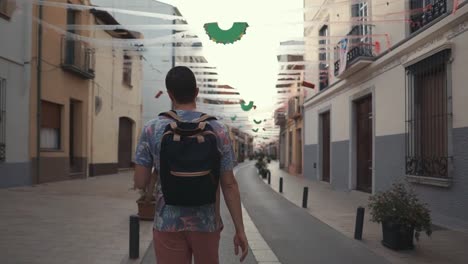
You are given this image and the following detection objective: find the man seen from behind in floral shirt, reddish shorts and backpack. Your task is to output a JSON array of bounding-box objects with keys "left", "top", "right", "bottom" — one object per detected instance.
[{"left": 134, "top": 67, "right": 248, "bottom": 264}]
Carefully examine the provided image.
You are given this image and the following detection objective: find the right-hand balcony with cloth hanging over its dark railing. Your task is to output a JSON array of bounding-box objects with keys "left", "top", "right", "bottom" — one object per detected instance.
[{"left": 334, "top": 25, "right": 374, "bottom": 77}]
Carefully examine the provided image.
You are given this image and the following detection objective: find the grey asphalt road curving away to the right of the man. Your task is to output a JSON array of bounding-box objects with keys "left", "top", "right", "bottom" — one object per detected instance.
[{"left": 237, "top": 166, "right": 388, "bottom": 264}]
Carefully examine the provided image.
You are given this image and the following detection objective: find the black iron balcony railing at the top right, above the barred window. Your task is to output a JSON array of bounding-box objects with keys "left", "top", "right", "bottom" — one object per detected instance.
[{"left": 410, "top": 0, "right": 447, "bottom": 33}]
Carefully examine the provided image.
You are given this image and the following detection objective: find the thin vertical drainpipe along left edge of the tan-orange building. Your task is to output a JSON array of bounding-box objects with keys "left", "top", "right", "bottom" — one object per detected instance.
[{"left": 36, "top": 2, "right": 43, "bottom": 184}]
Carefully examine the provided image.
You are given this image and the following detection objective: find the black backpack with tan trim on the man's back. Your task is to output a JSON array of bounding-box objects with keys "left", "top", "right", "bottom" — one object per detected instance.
[{"left": 159, "top": 111, "right": 221, "bottom": 207}]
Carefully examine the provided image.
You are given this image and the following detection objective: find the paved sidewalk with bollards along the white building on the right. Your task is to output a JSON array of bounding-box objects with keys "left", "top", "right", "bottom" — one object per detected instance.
[{"left": 264, "top": 161, "right": 468, "bottom": 264}]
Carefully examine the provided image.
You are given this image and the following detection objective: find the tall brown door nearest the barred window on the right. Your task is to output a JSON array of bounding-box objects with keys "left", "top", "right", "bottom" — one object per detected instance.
[{"left": 356, "top": 96, "right": 372, "bottom": 193}]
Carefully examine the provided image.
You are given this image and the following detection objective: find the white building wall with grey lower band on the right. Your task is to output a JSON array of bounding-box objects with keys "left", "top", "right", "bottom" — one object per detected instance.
[{"left": 304, "top": 1, "right": 468, "bottom": 227}]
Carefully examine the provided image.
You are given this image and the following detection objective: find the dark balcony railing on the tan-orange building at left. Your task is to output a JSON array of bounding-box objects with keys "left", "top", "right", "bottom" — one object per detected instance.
[{"left": 61, "top": 37, "right": 95, "bottom": 79}]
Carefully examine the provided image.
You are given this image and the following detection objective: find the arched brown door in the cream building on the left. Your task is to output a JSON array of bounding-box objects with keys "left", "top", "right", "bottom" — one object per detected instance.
[{"left": 118, "top": 117, "right": 133, "bottom": 168}]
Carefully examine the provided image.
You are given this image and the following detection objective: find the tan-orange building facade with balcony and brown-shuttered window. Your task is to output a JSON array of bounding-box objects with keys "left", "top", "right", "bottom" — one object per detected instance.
[{"left": 30, "top": 0, "right": 95, "bottom": 183}]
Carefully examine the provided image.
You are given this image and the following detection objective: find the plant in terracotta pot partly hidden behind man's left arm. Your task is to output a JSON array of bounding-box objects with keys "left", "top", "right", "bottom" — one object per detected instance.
[{"left": 136, "top": 172, "right": 157, "bottom": 221}]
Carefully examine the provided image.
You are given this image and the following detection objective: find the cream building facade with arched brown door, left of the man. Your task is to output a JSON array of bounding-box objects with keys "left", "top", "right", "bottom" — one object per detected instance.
[{"left": 88, "top": 11, "right": 144, "bottom": 176}]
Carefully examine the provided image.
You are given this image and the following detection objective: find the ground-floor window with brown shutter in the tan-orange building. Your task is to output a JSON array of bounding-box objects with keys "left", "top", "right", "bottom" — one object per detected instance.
[{"left": 40, "top": 101, "right": 62, "bottom": 150}]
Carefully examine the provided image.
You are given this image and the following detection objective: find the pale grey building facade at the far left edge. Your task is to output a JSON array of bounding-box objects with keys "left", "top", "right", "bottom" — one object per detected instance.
[{"left": 0, "top": 0, "right": 33, "bottom": 188}]
